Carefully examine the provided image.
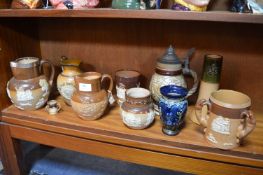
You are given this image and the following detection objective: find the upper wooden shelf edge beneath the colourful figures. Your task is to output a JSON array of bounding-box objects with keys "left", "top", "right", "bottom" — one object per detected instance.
[{"left": 0, "top": 8, "right": 263, "bottom": 24}]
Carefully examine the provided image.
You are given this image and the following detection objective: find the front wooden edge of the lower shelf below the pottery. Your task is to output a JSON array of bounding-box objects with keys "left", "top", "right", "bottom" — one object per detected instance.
[{"left": 2, "top": 106, "right": 263, "bottom": 168}]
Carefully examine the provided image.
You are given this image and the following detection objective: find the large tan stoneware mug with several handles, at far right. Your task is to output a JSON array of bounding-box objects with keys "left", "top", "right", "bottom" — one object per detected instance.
[{"left": 195, "top": 89, "right": 256, "bottom": 149}]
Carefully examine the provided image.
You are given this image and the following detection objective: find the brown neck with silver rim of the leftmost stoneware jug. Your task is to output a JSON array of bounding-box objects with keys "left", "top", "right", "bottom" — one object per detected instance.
[{"left": 10, "top": 57, "right": 40, "bottom": 80}]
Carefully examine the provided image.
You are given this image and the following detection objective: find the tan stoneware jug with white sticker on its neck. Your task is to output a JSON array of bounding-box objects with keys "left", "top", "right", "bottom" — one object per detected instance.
[{"left": 71, "top": 72, "right": 113, "bottom": 120}]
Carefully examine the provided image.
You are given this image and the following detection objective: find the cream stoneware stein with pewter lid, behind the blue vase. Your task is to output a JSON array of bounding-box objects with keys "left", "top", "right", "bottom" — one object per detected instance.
[{"left": 150, "top": 46, "right": 198, "bottom": 113}]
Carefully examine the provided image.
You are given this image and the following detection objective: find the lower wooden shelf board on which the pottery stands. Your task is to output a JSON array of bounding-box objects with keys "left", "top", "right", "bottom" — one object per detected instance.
[{"left": 2, "top": 99, "right": 263, "bottom": 168}]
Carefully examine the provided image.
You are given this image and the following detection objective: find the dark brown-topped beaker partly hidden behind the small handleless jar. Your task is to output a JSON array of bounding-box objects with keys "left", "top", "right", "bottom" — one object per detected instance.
[{"left": 115, "top": 70, "right": 140, "bottom": 105}]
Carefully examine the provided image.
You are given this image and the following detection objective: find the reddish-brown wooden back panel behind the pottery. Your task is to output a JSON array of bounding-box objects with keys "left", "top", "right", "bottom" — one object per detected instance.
[{"left": 39, "top": 19, "right": 263, "bottom": 111}]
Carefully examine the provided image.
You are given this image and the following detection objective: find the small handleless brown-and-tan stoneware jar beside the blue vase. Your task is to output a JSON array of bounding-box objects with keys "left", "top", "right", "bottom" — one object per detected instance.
[{"left": 120, "top": 87, "right": 155, "bottom": 129}]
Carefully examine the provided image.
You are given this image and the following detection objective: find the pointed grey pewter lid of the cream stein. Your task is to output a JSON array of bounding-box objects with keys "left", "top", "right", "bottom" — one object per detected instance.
[{"left": 157, "top": 45, "right": 182, "bottom": 71}]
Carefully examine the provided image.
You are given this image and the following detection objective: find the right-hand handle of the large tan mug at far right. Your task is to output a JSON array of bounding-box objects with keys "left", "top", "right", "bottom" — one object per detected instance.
[{"left": 237, "top": 110, "right": 256, "bottom": 139}]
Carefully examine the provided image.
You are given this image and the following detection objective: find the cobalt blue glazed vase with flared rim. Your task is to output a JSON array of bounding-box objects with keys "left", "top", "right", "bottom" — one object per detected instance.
[{"left": 159, "top": 85, "right": 188, "bottom": 135}]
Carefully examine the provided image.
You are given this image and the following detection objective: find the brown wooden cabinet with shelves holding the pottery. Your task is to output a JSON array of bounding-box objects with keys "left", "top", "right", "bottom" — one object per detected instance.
[{"left": 0, "top": 1, "right": 263, "bottom": 174}]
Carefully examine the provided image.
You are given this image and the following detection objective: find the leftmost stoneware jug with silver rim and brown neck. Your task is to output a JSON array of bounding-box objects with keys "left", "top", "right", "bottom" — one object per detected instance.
[{"left": 7, "top": 57, "right": 54, "bottom": 110}]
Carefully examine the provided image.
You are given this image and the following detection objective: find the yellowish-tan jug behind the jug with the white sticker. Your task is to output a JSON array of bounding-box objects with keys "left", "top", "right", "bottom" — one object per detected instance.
[{"left": 57, "top": 57, "right": 82, "bottom": 105}]
